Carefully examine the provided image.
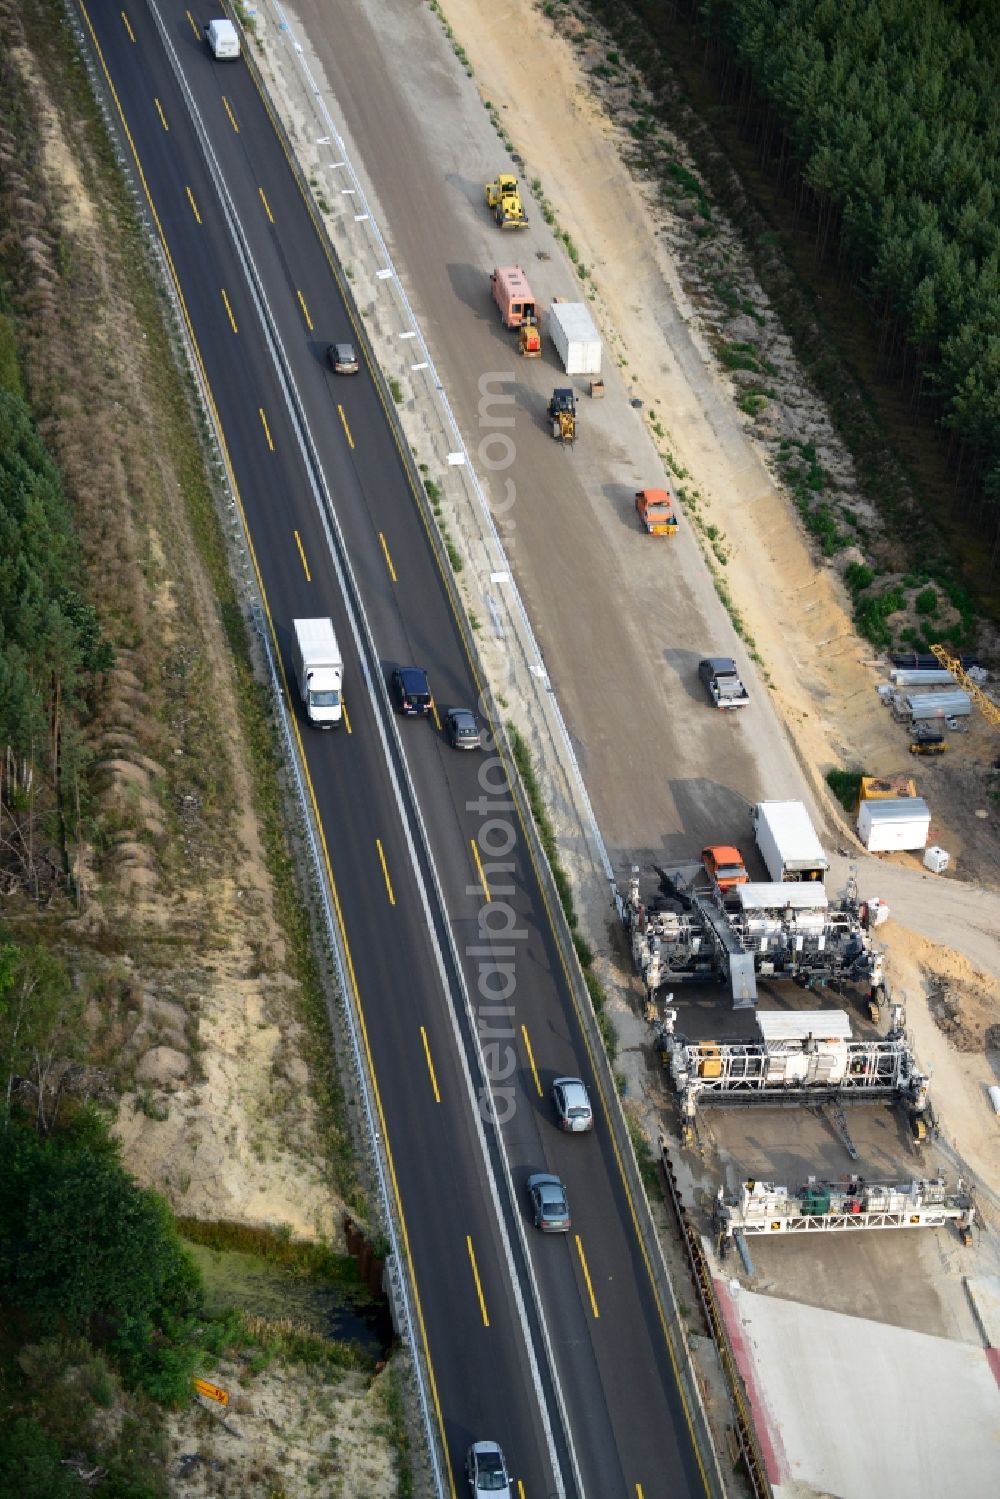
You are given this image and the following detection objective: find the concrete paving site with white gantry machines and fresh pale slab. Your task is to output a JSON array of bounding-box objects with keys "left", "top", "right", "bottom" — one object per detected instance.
[{"left": 613, "top": 784, "right": 1000, "bottom": 1495}]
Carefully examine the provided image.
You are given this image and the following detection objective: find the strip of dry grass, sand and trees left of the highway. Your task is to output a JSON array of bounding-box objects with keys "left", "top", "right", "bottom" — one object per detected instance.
[{"left": 0, "top": 0, "right": 405, "bottom": 1499}]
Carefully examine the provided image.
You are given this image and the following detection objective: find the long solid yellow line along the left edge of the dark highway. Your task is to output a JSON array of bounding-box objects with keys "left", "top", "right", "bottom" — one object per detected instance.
[{"left": 79, "top": 14, "right": 455, "bottom": 1499}]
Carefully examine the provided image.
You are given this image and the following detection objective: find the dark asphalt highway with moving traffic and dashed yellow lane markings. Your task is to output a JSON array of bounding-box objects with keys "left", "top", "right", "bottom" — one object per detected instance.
[{"left": 82, "top": 3, "right": 705, "bottom": 1499}]
